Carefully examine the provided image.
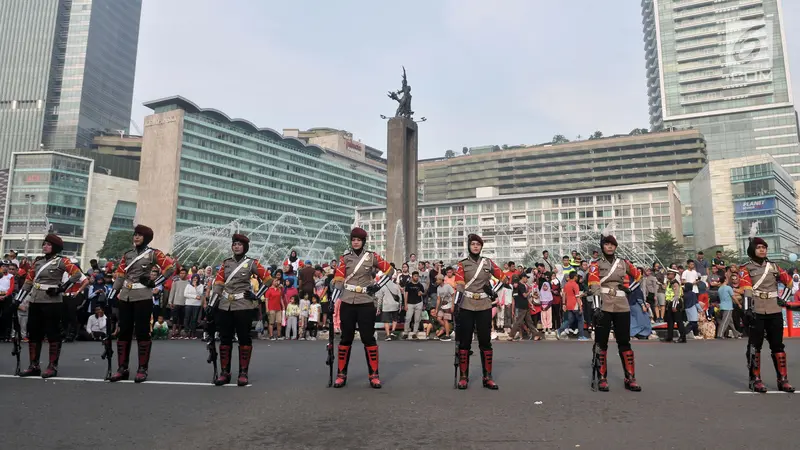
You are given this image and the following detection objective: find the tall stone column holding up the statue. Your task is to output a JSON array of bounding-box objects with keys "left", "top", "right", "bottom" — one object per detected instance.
[{"left": 385, "top": 117, "right": 418, "bottom": 270}]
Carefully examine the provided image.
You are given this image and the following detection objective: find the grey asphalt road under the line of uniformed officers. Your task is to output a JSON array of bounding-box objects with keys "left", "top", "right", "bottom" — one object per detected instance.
[{"left": 0, "top": 340, "right": 800, "bottom": 450}]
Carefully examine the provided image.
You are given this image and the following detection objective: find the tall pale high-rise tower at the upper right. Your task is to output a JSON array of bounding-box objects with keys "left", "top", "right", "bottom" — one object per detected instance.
[{"left": 642, "top": 0, "right": 800, "bottom": 176}]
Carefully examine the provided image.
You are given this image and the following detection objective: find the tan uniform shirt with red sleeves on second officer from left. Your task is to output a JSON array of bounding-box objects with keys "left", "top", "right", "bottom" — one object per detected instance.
[{"left": 114, "top": 247, "right": 175, "bottom": 302}]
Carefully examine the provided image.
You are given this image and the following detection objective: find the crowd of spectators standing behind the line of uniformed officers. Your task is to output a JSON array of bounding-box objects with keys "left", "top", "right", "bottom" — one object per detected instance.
[{"left": 0, "top": 244, "right": 800, "bottom": 342}]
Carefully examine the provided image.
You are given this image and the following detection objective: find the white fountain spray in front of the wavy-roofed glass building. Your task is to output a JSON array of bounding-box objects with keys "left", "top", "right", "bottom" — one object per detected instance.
[{"left": 171, "top": 213, "right": 347, "bottom": 266}]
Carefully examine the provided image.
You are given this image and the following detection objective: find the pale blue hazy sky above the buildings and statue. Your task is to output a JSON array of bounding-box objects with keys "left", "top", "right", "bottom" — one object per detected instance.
[{"left": 133, "top": 0, "right": 800, "bottom": 158}]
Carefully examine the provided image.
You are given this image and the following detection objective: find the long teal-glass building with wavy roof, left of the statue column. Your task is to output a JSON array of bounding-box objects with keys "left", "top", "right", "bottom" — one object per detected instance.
[{"left": 137, "top": 96, "right": 386, "bottom": 255}]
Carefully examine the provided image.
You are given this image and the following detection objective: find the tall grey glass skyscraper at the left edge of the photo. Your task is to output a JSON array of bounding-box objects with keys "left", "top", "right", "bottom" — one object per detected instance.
[{"left": 0, "top": 0, "right": 142, "bottom": 168}]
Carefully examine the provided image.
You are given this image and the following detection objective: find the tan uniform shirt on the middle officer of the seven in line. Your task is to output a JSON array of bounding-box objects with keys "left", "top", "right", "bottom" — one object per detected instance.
[{"left": 333, "top": 250, "right": 394, "bottom": 305}]
